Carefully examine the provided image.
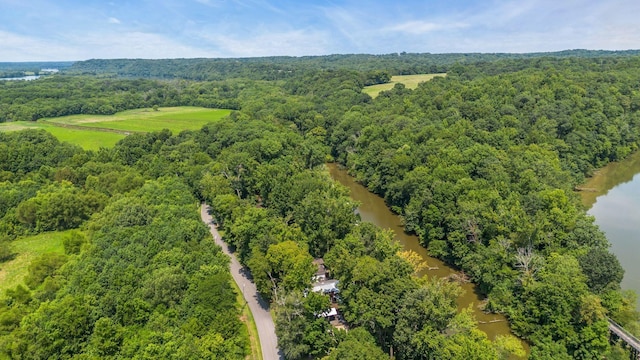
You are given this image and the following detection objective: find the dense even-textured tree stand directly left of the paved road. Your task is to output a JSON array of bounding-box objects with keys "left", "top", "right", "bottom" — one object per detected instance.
[{"left": 0, "top": 174, "right": 248, "bottom": 359}]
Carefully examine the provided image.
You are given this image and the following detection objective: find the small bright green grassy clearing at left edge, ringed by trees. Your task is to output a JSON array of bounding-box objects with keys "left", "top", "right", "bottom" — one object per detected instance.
[{"left": 0, "top": 230, "right": 73, "bottom": 294}]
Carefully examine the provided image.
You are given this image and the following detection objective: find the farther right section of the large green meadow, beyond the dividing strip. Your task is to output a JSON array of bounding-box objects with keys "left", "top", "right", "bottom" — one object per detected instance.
[{"left": 46, "top": 106, "right": 231, "bottom": 134}]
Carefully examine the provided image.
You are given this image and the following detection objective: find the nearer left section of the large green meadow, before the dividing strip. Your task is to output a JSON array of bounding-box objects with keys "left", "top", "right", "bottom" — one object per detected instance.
[{"left": 0, "top": 121, "right": 125, "bottom": 150}]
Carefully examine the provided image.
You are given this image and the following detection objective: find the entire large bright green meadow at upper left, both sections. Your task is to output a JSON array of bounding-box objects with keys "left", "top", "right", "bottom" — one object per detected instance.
[{"left": 0, "top": 106, "right": 231, "bottom": 150}]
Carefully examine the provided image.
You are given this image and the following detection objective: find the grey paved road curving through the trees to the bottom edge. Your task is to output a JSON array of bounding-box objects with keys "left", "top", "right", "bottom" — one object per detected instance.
[{"left": 200, "top": 204, "right": 284, "bottom": 360}]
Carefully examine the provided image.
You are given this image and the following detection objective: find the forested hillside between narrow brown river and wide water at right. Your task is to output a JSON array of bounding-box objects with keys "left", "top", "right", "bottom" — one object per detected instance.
[{"left": 329, "top": 57, "right": 640, "bottom": 358}]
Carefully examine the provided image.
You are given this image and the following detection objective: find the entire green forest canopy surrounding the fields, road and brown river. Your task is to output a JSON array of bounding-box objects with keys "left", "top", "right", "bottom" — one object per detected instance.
[{"left": 0, "top": 53, "right": 640, "bottom": 359}]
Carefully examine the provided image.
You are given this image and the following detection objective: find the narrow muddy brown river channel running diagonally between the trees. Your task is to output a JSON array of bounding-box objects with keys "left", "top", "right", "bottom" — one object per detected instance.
[{"left": 328, "top": 164, "right": 526, "bottom": 346}]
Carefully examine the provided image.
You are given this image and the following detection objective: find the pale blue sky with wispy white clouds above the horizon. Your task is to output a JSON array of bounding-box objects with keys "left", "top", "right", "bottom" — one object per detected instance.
[{"left": 0, "top": 0, "right": 640, "bottom": 62}]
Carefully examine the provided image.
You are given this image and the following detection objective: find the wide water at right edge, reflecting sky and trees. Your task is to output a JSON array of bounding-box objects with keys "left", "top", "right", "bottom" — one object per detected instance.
[{"left": 581, "top": 151, "right": 640, "bottom": 310}]
